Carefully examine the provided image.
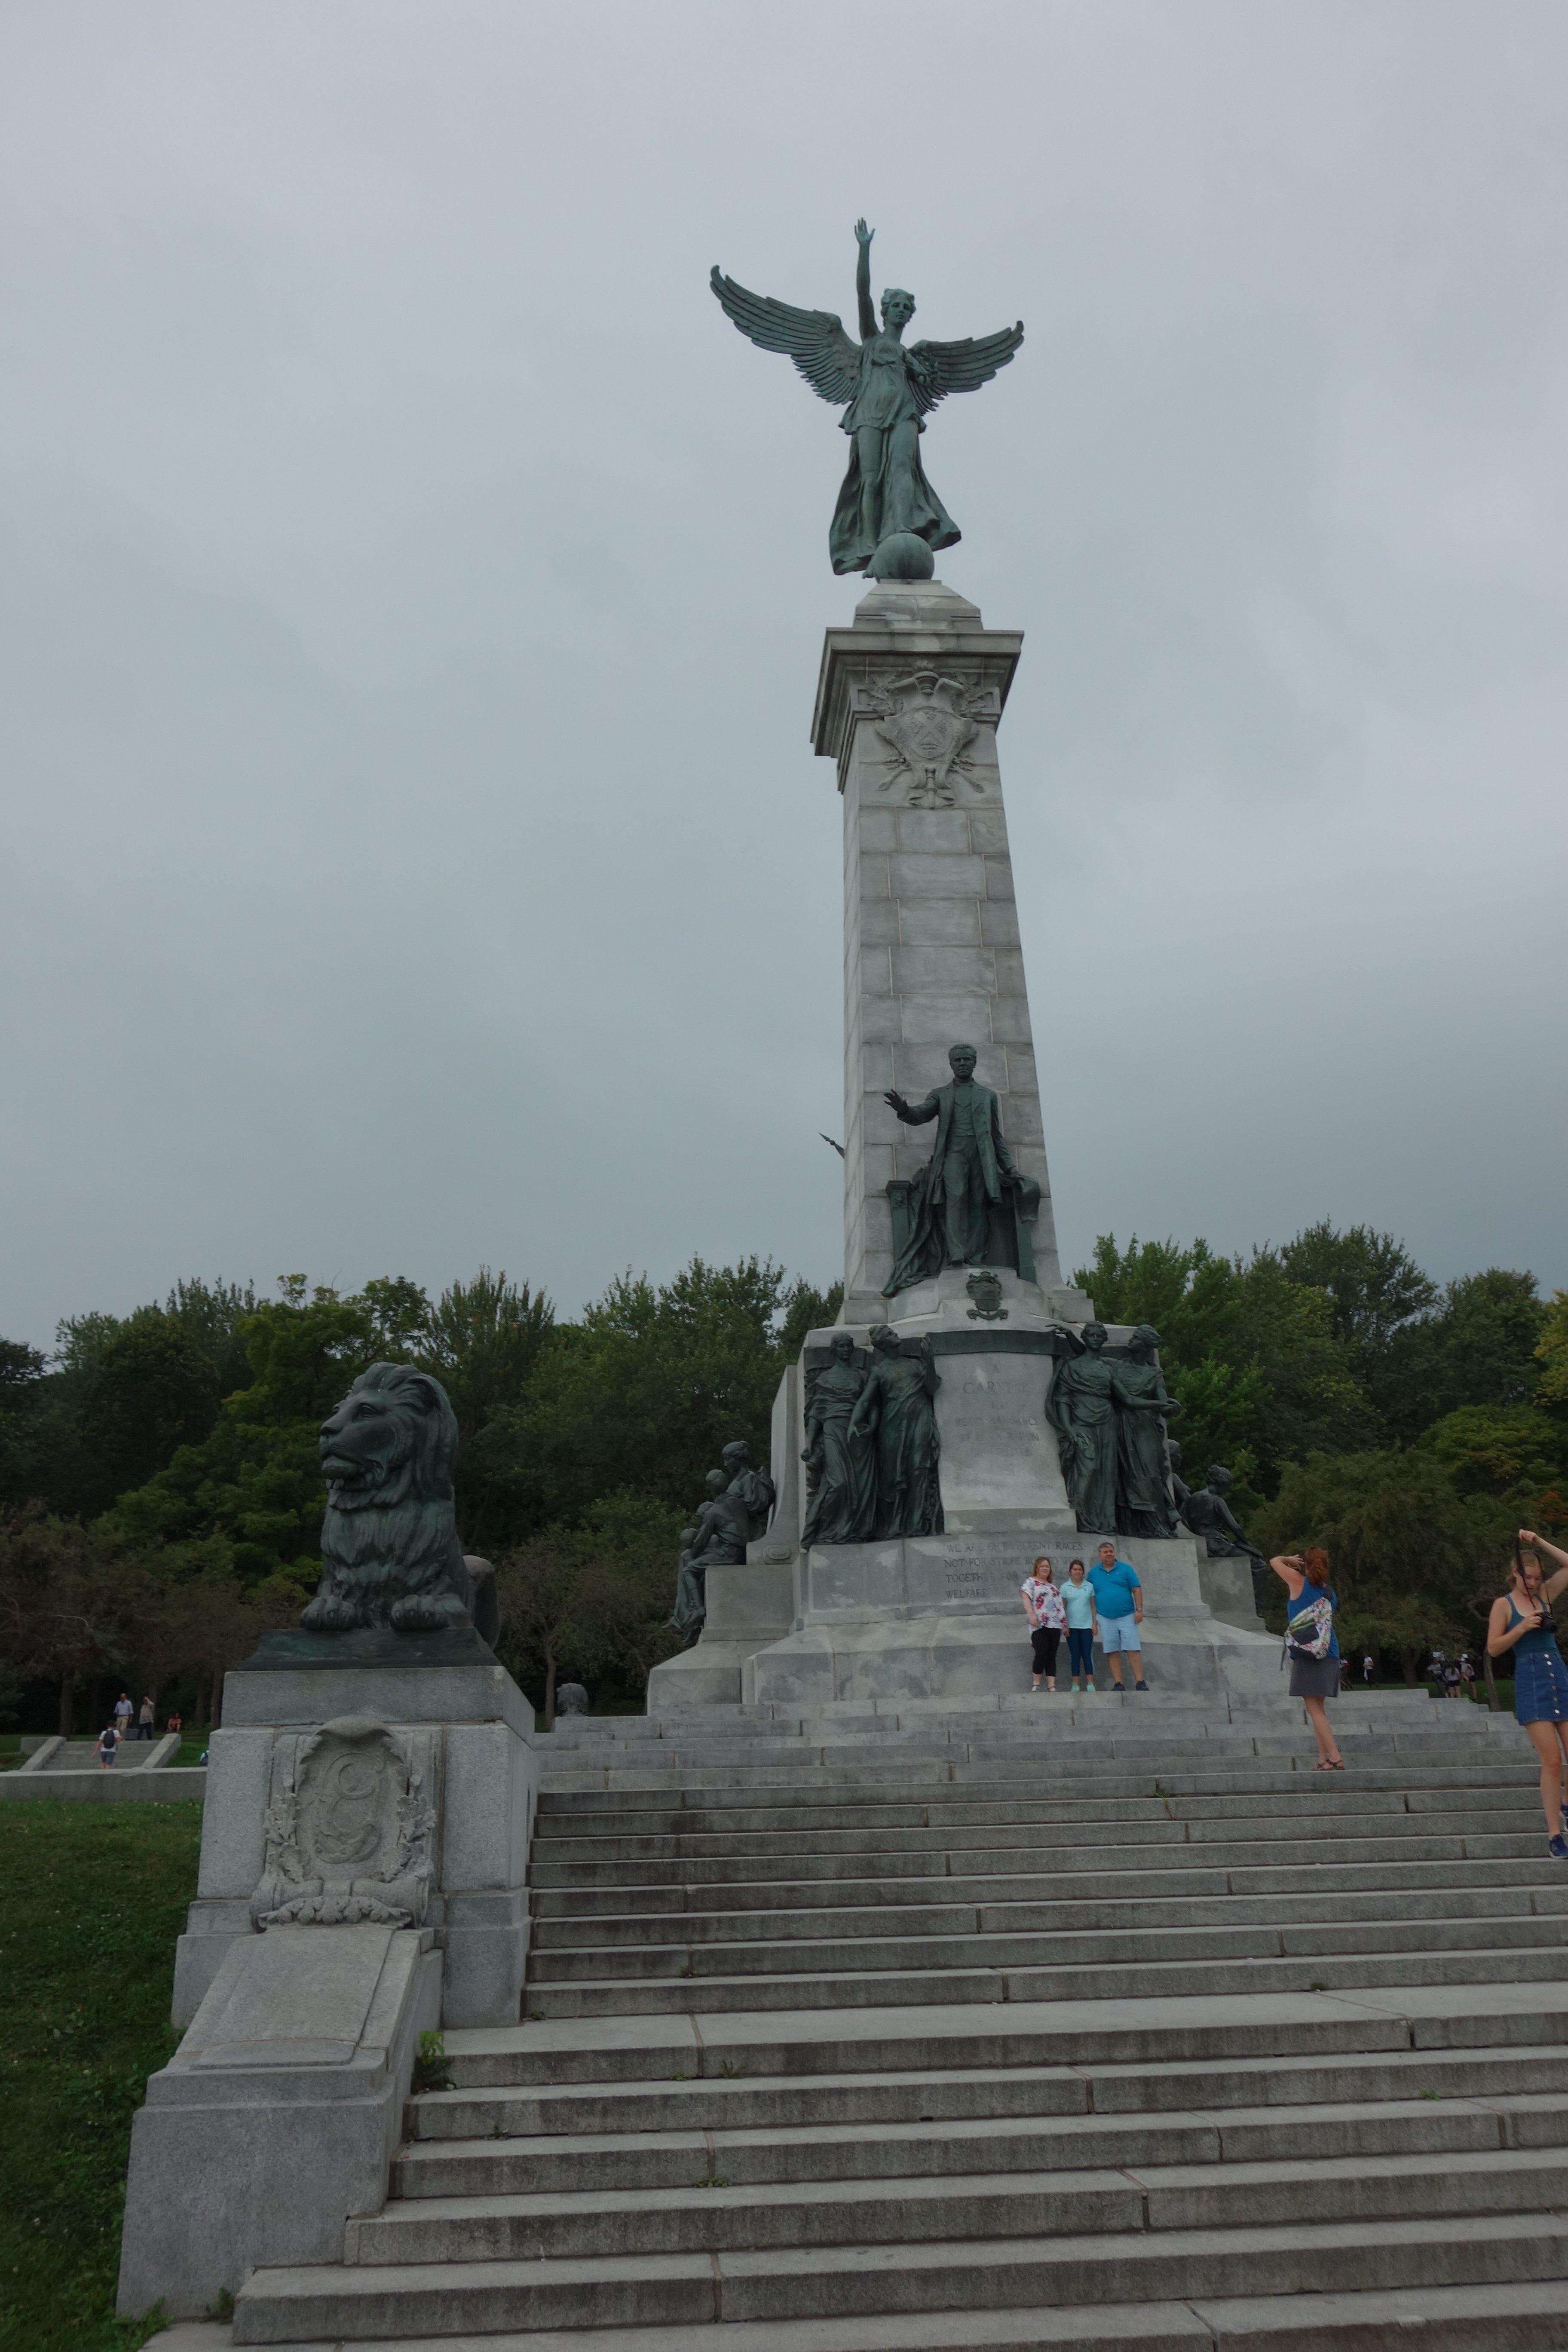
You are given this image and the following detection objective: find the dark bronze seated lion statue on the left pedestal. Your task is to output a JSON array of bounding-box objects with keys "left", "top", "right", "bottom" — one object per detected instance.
[{"left": 301, "top": 1364, "right": 501, "bottom": 1642}]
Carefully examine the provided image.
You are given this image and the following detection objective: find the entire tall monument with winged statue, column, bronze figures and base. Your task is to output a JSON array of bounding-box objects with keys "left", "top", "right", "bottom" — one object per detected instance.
[{"left": 649, "top": 224, "right": 1279, "bottom": 1710}]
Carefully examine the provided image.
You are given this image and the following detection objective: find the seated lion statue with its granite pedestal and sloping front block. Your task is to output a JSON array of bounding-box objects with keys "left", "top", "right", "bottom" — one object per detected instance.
[{"left": 120, "top": 1364, "right": 543, "bottom": 2317}]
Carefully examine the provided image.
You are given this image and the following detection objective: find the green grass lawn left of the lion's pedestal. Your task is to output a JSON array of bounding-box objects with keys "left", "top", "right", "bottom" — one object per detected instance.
[{"left": 0, "top": 1799, "right": 202, "bottom": 2352}]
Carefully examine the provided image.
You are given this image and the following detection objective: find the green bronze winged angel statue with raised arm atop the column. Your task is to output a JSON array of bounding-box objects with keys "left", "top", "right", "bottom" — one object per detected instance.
[{"left": 712, "top": 221, "right": 1023, "bottom": 579}]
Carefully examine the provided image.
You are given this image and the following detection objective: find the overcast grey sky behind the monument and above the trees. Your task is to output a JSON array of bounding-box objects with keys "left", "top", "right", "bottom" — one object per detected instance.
[{"left": 0, "top": 0, "right": 1568, "bottom": 1345}]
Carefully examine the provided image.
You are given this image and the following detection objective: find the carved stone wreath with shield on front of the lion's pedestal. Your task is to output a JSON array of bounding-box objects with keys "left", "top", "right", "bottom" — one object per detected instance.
[{"left": 251, "top": 1715, "right": 435, "bottom": 1929}]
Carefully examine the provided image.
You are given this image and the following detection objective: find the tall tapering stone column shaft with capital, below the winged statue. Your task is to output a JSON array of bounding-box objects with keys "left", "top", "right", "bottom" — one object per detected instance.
[{"left": 811, "top": 581, "right": 1063, "bottom": 1324}]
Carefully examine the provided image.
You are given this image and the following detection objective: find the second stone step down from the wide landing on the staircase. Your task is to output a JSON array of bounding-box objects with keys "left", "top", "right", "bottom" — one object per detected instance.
[{"left": 392, "top": 2093, "right": 1568, "bottom": 2202}]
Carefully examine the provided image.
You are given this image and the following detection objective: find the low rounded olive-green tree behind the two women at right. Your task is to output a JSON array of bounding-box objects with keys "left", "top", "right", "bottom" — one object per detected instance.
[{"left": 1251, "top": 1449, "right": 1504, "bottom": 1684}]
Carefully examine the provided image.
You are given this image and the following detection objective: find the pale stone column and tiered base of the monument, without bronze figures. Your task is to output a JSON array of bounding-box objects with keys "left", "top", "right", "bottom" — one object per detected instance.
[{"left": 649, "top": 581, "right": 1279, "bottom": 1710}]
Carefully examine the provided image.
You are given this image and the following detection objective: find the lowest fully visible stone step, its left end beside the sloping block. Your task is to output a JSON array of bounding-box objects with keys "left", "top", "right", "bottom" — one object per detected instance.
[{"left": 233, "top": 2213, "right": 1568, "bottom": 2347}]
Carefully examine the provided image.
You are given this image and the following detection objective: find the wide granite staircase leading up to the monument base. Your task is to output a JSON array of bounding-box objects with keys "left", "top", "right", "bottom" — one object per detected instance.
[{"left": 233, "top": 1694, "right": 1568, "bottom": 2352}]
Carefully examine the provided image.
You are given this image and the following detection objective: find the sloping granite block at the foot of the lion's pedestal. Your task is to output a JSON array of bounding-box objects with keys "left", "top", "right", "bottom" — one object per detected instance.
[{"left": 117, "top": 1926, "right": 442, "bottom": 2319}]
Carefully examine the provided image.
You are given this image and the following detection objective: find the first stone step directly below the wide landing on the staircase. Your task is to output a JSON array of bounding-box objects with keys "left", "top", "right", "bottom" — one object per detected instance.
[{"left": 400, "top": 2044, "right": 1568, "bottom": 2145}]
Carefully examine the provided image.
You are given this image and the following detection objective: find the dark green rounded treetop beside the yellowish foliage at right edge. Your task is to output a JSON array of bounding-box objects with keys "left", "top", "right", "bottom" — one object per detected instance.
[{"left": 1371, "top": 1265, "right": 1547, "bottom": 1442}]
